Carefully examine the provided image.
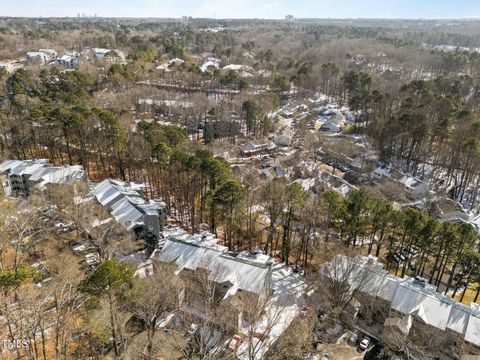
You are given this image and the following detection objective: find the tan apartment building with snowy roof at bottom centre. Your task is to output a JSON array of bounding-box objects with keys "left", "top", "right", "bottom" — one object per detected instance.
[{"left": 152, "top": 234, "right": 273, "bottom": 331}]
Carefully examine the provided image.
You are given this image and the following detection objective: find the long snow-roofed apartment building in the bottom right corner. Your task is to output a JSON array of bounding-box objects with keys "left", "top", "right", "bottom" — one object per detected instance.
[{"left": 321, "top": 255, "right": 480, "bottom": 352}]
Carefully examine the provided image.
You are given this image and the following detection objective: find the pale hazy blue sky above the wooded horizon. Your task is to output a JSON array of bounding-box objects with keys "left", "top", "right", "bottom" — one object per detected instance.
[{"left": 0, "top": 0, "right": 480, "bottom": 19}]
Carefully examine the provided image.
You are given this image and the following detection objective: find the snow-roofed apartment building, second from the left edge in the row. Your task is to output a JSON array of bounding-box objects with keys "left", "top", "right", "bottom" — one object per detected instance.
[{"left": 92, "top": 179, "right": 166, "bottom": 241}]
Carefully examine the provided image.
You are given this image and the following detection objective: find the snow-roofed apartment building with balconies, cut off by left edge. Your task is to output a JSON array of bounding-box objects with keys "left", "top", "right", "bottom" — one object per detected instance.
[{"left": 0, "top": 159, "right": 87, "bottom": 197}]
